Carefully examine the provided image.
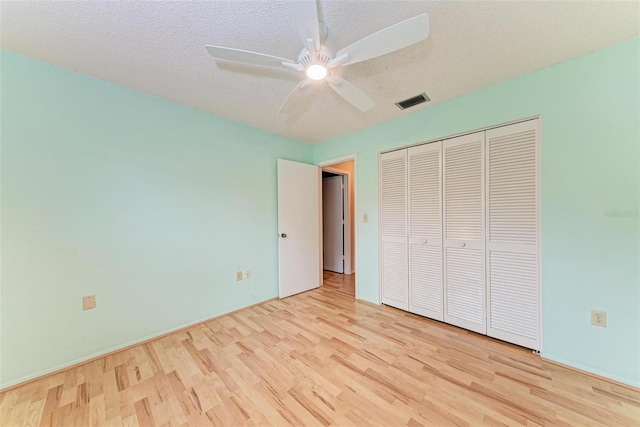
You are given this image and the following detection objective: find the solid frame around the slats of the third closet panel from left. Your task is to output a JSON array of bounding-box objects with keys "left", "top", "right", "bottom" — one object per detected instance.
[{"left": 442, "top": 131, "right": 487, "bottom": 335}]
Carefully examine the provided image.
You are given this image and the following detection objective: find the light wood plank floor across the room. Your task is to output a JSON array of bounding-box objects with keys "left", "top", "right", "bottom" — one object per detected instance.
[{"left": 0, "top": 274, "right": 640, "bottom": 427}]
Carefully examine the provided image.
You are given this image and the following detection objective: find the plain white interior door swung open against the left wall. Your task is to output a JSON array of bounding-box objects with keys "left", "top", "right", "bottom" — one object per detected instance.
[{"left": 278, "top": 159, "right": 320, "bottom": 298}]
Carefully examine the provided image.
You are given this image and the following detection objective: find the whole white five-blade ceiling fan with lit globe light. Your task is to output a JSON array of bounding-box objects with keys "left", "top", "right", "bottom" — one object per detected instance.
[{"left": 206, "top": 0, "right": 429, "bottom": 113}]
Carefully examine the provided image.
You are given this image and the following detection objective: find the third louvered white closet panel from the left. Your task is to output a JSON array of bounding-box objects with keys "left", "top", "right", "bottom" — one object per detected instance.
[{"left": 443, "top": 132, "right": 486, "bottom": 334}]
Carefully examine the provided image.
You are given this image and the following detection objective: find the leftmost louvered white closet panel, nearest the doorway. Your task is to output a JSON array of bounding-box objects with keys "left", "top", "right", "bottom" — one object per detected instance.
[{"left": 380, "top": 149, "right": 409, "bottom": 310}]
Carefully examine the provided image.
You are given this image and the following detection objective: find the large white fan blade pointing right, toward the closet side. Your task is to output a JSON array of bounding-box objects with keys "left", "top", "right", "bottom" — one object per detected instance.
[{"left": 336, "top": 13, "right": 429, "bottom": 65}]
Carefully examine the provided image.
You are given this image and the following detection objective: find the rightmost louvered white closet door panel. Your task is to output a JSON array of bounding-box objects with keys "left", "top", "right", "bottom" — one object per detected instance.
[{"left": 486, "top": 120, "right": 540, "bottom": 350}]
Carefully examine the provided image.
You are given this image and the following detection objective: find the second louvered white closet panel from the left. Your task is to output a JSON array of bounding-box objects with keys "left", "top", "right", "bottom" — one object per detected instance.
[{"left": 408, "top": 142, "right": 444, "bottom": 321}]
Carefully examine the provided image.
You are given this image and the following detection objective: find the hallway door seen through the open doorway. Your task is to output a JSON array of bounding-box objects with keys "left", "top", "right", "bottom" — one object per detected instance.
[{"left": 322, "top": 175, "right": 345, "bottom": 273}]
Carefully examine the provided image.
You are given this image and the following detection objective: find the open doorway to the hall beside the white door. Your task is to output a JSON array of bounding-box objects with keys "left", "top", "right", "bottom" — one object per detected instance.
[{"left": 321, "top": 160, "right": 356, "bottom": 297}]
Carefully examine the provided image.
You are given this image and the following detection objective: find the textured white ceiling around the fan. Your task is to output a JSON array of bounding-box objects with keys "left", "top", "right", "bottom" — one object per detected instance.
[{"left": 0, "top": 0, "right": 640, "bottom": 143}]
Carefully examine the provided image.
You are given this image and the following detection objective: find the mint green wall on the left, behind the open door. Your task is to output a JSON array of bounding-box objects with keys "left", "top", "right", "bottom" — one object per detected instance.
[{"left": 0, "top": 52, "right": 312, "bottom": 386}]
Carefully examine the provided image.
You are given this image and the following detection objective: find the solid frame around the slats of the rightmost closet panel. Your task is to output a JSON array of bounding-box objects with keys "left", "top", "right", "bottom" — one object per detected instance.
[{"left": 484, "top": 117, "right": 542, "bottom": 353}]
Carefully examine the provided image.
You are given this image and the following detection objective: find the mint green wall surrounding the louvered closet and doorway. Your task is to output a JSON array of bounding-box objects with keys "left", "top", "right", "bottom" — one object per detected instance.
[{"left": 314, "top": 39, "right": 640, "bottom": 386}]
